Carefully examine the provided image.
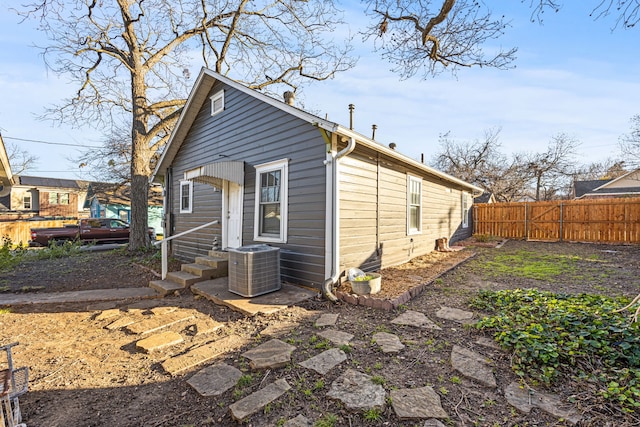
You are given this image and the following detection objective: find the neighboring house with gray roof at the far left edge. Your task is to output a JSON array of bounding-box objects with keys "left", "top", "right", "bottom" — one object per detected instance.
[{"left": 0, "top": 175, "right": 88, "bottom": 221}]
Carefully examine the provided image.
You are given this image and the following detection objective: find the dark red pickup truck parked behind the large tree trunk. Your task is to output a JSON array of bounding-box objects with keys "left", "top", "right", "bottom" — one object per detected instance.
[{"left": 29, "top": 218, "right": 155, "bottom": 246}]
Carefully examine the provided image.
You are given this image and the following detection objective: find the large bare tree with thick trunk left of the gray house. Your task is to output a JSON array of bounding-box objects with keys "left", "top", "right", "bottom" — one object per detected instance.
[{"left": 21, "top": 0, "right": 353, "bottom": 250}]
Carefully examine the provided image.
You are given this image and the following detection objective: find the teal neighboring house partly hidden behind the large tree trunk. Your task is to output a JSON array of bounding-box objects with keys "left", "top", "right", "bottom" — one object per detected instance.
[{"left": 84, "top": 182, "right": 162, "bottom": 234}]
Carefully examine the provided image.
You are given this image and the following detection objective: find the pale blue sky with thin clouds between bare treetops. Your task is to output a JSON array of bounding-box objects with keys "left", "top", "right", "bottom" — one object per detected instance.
[{"left": 0, "top": 0, "right": 640, "bottom": 180}]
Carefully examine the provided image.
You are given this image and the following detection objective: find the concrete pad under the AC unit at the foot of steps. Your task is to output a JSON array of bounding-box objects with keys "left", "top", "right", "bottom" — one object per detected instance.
[{"left": 191, "top": 277, "right": 317, "bottom": 316}]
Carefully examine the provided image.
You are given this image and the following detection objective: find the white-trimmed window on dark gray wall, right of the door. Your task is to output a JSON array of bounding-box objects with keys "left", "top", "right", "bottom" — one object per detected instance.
[{"left": 253, "top": 159, "right": 289, "bottom": 243}]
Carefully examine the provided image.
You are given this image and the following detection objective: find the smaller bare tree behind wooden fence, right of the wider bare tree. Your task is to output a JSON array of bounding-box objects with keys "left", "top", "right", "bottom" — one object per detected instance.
[{"left": 525, "top": 133, "right": 579, "bottom": 201}]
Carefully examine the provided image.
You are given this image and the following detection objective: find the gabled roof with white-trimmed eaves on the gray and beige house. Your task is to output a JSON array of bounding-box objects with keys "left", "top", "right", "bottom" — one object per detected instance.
[{"left": 151, "top": 67, "right": 482, "bottom": 193}]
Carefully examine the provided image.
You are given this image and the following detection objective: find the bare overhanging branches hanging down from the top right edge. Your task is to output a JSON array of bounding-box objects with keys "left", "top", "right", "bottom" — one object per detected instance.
[{"left": 364, "top": 0, "right": 640, "bottom": 78}]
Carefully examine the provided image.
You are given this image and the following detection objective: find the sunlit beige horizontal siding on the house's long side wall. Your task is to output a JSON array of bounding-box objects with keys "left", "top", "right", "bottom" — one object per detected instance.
[{"left": 340, "top": 148, "right": 469, "bottom": 271}]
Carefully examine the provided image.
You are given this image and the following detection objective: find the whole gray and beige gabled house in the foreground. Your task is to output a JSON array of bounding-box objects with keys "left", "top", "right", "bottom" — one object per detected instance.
[{"left": 152, "top": 69, "right": 482, "bottom": 288}]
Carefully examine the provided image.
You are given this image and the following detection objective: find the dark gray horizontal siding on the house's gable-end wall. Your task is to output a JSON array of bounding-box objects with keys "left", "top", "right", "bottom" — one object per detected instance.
[{"left": 172, "top": 83, "right": 326, "bottom": 287}]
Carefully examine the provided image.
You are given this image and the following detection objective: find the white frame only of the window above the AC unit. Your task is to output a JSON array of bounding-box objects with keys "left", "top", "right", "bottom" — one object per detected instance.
[{"left": 253, "top": 159, "right": 289, "bottom": 243}]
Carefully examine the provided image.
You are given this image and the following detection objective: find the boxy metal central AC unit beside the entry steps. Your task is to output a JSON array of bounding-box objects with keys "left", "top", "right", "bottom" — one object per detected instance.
[{"left": 229, "top": 245, "right": 281, "bottom": 297}]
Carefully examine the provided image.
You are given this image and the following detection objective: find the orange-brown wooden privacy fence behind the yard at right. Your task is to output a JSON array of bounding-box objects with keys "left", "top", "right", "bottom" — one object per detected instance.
[{"left": 473, "top": 197, "right": 640, "bottom": 243}]
